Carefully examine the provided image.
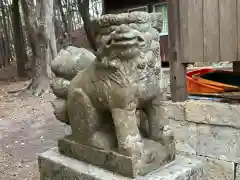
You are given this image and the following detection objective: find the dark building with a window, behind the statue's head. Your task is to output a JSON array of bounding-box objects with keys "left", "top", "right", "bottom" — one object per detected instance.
[{"left": 103, "top": 0, "right": 168, "bottom": 64}]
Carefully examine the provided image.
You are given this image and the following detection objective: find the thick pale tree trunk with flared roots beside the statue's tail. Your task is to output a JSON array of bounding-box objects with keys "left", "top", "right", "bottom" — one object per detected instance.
[{"left": 21, "top": 0, "right": 55, "bottom": 96}]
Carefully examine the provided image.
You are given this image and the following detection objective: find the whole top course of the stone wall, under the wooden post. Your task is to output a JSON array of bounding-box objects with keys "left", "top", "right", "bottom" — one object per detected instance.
[{"left": 165, "top": 100, "right": 240, "bottom": 128}]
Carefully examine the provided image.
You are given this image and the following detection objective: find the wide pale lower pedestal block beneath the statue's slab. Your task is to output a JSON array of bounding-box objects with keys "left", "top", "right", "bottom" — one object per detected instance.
[{"left": 38, "top": 148, "right": 202, "bottom": 180}]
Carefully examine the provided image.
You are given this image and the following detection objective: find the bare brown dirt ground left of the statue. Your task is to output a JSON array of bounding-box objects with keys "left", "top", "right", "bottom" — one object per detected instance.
[{"left": 0, "top": 65, "right": 70, "bottom": 180}]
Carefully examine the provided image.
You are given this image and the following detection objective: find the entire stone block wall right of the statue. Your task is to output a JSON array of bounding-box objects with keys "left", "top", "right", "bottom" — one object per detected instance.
[{"left": 164, "top": 100, "right": 240, "bottom": 180}]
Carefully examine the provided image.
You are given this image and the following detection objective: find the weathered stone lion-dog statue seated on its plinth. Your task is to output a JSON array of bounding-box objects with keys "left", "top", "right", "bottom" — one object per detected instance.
[{"left": 52, "top": 12, "right": 175, "bottom": 178}]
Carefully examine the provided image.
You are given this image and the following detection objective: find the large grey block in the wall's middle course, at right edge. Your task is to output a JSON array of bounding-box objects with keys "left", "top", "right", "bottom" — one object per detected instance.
[{"left": 197, "top": 124, "right": 240, "bottom": 162}]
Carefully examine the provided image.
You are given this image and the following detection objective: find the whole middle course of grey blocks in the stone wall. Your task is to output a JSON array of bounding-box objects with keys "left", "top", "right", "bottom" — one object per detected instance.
[{"left": 169, "top": 120, "right": 240, "bottom": 163}]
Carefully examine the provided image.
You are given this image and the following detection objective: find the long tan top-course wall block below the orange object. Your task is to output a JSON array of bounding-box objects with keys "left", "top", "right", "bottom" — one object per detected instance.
[{"left": 185, "top": 100, "right": 240, "bottom": 128}]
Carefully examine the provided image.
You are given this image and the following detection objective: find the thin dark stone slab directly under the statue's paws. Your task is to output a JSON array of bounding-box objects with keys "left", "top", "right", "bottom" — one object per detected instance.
[{"left": 58, "top": 135, "right": 175, "bottom": 178}]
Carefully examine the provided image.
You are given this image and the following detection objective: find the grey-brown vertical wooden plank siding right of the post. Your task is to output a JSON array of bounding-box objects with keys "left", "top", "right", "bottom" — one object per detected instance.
[{"left": 179, "top": 0, "right": 240, "bottom": 63}]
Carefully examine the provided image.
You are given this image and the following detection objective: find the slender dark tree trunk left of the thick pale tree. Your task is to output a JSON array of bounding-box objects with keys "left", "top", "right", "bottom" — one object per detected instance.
[{"left": 12, "top": 0, "right": 28, "bottom": 78}]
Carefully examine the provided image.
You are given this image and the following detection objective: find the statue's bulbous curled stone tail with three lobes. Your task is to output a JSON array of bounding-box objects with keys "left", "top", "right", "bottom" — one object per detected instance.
[{"left": 51, "top": 46, "right": 95, "bottom": 124}]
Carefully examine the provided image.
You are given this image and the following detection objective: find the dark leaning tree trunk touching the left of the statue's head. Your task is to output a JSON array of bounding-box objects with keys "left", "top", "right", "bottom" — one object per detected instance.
[{"left": 78, "top": 0, "right": 97, "bottom": 51}]
